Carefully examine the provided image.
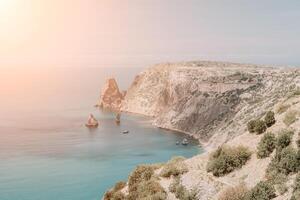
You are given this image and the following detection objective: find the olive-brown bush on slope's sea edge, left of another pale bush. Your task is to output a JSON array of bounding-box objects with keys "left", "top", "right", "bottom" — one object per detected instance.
[{"left": 128, "top": 165, "right": 154, "bottom": 192}]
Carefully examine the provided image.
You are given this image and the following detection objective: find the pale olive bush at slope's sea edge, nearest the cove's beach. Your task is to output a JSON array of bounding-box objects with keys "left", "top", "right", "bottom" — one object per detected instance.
[{"left": 160, "top": 157, "right": 188, "bottom": 177}]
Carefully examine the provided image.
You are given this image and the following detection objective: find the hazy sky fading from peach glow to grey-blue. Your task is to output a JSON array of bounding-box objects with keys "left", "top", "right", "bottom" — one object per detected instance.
[{"left": 0, "top": 0, "right": 300, "bottom": 66}]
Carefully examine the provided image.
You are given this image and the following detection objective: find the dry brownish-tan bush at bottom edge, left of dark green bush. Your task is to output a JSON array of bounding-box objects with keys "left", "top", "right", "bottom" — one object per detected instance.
[{"left": 218, "top": 184, "right": 248, "bottom": 200}]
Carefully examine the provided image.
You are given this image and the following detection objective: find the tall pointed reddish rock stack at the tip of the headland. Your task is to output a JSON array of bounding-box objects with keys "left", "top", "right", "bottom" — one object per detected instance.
[{"left": 97, "top": 78, "right": 124, "bottom": 111}]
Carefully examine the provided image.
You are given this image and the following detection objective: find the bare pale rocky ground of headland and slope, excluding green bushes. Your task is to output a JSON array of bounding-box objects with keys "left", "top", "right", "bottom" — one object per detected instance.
[{"left": 102, "top": 61, "right": 300, "bottom": 200}]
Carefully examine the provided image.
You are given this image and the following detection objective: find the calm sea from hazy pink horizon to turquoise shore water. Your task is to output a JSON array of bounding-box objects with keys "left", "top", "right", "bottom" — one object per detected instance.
[{"left": 0, "top": 68, "right": 201, "bottom": 200}]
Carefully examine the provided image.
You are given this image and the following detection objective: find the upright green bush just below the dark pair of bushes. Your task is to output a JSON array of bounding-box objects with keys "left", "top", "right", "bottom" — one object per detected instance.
[{"left": 257, "top": 133, "right": 276, "bottom": 158}]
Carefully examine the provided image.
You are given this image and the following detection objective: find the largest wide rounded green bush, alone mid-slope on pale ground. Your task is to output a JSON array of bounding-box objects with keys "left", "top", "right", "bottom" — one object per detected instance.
[{"left": 207, "top": 146, "right": 251, "bottom": 176}]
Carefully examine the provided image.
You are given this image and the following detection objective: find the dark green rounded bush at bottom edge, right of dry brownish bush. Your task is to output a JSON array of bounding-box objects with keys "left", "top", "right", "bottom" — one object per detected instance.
[{"left": 245, "top": 181, "right": 276, "bottom": 200}]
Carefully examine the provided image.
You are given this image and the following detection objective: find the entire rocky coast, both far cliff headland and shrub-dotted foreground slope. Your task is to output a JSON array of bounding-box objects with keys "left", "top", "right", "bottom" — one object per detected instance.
[{"left": 104, "top": 61, "right": 300, "bottom": 200}]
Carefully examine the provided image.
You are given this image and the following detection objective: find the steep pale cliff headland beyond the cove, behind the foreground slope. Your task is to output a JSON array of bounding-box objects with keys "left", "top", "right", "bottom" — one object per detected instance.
[{"left": 121, "top": 62, "right": 295, "bottom": 142}]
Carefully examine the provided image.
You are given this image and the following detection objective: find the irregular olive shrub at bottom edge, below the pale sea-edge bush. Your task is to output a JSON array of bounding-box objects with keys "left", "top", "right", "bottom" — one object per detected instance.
[{"left": 169, "top": 177, "right": 198, "bottom": 200}]
